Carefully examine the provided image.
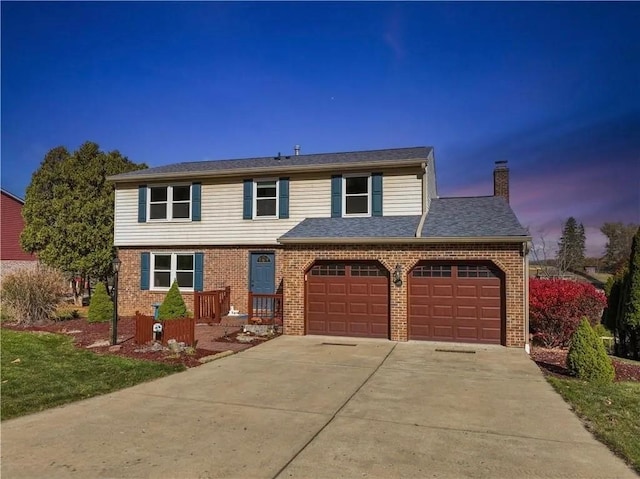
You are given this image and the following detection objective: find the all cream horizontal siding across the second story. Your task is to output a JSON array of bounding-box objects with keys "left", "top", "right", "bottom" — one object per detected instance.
[{"left": 115, "top": 170, "right": 422, "bottom": 246}]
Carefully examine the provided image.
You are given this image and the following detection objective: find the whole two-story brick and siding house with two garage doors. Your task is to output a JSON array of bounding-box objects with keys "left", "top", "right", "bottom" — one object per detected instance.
[{"left": 109, "top": 147, "right": 530, "bottom": 347}]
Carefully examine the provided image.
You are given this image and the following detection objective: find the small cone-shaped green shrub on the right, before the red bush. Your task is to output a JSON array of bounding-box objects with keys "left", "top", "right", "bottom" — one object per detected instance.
[{"left": 567, "top": 319, "right": 616, "bottom": 383}]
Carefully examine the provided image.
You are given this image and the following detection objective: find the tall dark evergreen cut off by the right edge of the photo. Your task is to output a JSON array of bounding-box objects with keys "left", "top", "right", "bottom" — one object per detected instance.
[{"left": 621, "top": 228, "right": 640, "bottom": 359}]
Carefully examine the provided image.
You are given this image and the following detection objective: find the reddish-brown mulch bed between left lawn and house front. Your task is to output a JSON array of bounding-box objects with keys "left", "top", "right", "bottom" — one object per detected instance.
[{"left": 2, "top": 318, "right": 263, "bottom": 368}]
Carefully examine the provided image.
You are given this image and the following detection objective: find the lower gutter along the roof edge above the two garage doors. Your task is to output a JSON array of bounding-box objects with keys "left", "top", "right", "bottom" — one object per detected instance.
[{"left": 277, "top": 236, "right": 531, "bottom": 245}]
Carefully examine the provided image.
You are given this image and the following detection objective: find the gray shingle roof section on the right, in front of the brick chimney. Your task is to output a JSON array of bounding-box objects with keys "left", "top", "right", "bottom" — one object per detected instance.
[{"left": 422, "top": 196, "right": 529, "bottom": 238}]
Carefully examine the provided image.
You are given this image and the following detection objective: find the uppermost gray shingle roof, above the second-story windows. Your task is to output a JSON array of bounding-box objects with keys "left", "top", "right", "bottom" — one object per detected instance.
[{"left": 109, "top": 146, "right": 432, "bottom": 181}]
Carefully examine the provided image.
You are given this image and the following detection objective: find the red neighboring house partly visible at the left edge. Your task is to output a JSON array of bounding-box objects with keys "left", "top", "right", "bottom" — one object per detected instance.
[{"left": 0, "top": 189, "right": 38, "bottom": 283}]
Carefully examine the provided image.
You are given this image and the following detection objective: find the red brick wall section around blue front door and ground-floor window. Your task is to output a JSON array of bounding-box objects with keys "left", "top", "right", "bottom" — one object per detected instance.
[{"left": 118, "top": 246, "right": 283, "bottom": 316}]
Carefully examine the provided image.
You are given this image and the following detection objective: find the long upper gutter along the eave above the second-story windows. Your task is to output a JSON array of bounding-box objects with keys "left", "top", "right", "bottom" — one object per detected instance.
[{"left": 107, "top": 158, "right": 424, "bottom": 184}]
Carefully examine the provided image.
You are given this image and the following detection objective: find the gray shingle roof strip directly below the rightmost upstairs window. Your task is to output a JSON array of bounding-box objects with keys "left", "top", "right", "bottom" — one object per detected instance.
[{"left": 282, "top": 215, "right": 420, "bottom": 239}]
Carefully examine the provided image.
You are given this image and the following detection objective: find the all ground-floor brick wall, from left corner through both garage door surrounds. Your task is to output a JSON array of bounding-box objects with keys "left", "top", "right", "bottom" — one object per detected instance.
[{"left": 118, "top": 243, "right": 528, "bottom": 347}]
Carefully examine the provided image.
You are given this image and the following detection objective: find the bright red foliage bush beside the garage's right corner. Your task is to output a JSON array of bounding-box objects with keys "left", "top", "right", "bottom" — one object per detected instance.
[{"left": 529, "top": 278, "right": 607, "bottom": 348}]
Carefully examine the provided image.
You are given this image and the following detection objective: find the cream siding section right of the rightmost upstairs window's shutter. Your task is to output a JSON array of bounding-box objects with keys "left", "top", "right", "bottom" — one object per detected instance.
[{"left": 382, "top": 173, "right": 422, "bottom": 216}]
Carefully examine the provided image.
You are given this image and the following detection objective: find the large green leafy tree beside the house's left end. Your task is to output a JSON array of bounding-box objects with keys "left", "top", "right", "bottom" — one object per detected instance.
[{"left": 20, "top": 142, "right": 146, "bottom": 303}]
